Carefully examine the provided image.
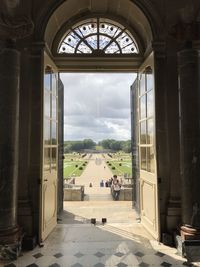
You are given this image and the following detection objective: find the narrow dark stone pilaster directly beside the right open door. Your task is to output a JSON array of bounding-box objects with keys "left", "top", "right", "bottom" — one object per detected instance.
[{"left": 152, "top": 40, "right": 170, "bottom": 233}]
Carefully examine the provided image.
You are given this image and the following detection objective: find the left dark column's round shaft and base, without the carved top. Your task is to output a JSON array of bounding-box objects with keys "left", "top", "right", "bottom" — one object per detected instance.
[{"left": 0, "top": 48, "right": 20, "bottom": 259}]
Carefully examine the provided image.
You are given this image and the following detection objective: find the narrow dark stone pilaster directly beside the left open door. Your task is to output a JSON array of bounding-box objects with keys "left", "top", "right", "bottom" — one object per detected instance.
[{"left": 29, "top": 42, "right": 45, "bottom": 239}]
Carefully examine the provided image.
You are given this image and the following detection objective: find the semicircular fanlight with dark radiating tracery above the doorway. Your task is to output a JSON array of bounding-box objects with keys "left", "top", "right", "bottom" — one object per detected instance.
[{"left": 58, "top": 18, "right": 139, "bottom": 55}]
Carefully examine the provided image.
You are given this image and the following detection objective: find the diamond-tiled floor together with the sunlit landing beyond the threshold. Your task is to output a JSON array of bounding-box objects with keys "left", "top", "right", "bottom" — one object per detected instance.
[{"left": 0, "top": 202, "right": 198, "bottom": 267}]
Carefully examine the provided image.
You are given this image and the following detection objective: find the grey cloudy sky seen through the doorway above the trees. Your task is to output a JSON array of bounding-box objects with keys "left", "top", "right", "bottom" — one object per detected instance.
[{"left": 61, "top": 73, "right": 135, "bottom": 142}]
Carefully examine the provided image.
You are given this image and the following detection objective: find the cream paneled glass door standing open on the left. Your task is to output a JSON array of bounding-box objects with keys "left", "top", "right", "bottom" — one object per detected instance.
[{"left": 40, "top": 54, "right": 58, "bottom": 242}]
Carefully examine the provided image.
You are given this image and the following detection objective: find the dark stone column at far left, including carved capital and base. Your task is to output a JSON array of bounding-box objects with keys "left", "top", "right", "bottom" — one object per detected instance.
[{"left": 0, "top": 9, "right": 33, "bottom": 260}]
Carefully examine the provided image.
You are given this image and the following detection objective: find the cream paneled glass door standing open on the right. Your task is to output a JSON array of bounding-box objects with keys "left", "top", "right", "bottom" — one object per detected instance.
[{"left": 137, "top": 53, "right": 160, "bottom": 239}]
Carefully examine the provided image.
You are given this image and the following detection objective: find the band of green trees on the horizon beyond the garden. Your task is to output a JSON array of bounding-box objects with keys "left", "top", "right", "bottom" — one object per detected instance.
[{"left": 64, "top": 139, "right": 131, "bottom": 153}]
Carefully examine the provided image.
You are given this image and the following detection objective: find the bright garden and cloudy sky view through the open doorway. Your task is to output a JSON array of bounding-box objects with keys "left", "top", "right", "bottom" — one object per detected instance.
[{"left": 58, "top": 73, "right": 136, "bottom": 220}]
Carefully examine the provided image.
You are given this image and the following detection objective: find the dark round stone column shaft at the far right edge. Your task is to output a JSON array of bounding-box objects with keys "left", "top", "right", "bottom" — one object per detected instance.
[{"left": 178, "top": 48, "right": 200, "bottom": 234}]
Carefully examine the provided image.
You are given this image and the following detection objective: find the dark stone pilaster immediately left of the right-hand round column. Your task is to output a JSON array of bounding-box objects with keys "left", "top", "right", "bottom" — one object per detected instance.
[{"left": 165, "top": 38, "right": 181, "bottom": 232}]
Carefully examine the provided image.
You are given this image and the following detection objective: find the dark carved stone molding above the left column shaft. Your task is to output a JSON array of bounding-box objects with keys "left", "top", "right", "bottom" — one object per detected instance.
[{"left": 0, "top": 14, "right": 34, "bottom": 39}]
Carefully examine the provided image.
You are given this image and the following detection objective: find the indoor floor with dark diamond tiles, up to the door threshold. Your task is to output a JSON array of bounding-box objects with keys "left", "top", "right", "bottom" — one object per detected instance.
[{"left": 1, "top": 224, "right": 198, "bottom": 267}]
